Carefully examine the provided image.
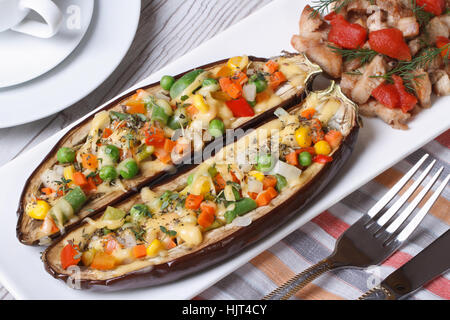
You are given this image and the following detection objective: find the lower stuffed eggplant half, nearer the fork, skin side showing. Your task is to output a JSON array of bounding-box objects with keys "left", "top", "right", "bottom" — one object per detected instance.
[{"left": 43, "top": 84, "right": 359, "bottom": 290}]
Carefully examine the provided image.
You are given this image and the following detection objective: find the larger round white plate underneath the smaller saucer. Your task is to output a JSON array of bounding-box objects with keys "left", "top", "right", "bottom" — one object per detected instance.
[{"left": 0, "top": 0, "right": 141, "bottom": 128}]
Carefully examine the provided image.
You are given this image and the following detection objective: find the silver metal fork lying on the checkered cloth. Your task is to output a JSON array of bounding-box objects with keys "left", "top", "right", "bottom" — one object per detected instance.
[{"left": 263, "top": 154, "right": 450, "bottom": 300}]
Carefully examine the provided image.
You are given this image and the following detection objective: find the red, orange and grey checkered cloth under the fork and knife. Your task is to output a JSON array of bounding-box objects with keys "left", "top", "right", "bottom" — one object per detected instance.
[{"left": 197, "top": 130, "right": 450, "bottom": 300}]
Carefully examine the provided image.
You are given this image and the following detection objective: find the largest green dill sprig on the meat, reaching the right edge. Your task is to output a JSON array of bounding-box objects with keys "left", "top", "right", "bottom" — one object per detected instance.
[{"left": 371, "top": 44, "right": 450, "bottom": 92}]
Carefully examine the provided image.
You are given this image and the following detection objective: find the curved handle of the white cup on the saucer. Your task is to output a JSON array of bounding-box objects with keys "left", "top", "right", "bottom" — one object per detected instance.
[{"left": 11, "top": 0, "right": 63, "bottom": 38}]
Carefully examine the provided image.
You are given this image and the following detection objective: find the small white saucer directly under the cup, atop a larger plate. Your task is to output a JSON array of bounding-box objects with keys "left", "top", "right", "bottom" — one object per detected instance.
[{"left": 0, "top": 0, "right": 94, "bottom": 88}]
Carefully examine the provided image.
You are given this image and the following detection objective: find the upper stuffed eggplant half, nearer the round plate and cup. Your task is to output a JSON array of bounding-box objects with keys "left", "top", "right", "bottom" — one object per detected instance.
[{"left": 17, "top": 54, "right": 320, "bottom": 245}]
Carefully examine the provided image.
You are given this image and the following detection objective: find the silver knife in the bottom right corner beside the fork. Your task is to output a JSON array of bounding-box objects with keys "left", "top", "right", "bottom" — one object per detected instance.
[{"left": 359, "top": 230, "right": 450, "bottom": 300}]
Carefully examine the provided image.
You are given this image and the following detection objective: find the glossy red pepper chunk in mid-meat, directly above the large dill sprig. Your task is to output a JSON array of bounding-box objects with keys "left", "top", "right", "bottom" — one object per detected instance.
[{"left": 369, "top": 28, "right": 411, "bottom": 61}]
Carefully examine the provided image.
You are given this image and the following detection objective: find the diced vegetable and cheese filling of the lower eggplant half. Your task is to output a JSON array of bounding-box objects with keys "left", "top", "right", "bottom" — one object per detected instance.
[{"left": 58, "top": 102, "right": 343, "bottom": 270}]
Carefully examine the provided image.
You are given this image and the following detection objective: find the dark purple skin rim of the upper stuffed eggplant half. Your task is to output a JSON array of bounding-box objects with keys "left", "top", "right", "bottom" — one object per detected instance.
[{"left": 16, "top": 52, "right": 317, "bottom": 246}]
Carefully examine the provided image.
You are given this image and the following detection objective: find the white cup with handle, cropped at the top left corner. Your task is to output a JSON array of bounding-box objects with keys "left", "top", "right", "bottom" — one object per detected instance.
[{"left": 0, "top": 0, "right": 63, "bottom": 38}]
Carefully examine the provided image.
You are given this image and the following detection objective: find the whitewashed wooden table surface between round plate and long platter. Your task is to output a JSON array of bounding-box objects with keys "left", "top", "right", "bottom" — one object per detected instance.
[{"left": 0, "top": 0, "right": 272, "bottom": 299}]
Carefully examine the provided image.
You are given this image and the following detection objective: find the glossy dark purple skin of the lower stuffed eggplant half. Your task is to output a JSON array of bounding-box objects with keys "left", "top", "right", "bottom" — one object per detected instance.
[{"left": 42, "top": 123, "right": 359, "bottom": 292}]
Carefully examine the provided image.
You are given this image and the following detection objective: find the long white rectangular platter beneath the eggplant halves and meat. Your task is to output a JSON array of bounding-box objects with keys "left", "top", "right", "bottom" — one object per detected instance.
[{"left": 0, "top": 0, "right": 450, "bottom": 299}]
